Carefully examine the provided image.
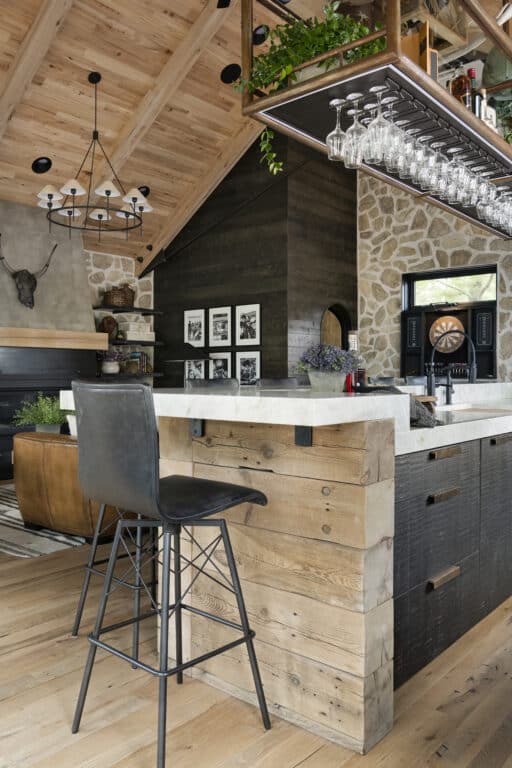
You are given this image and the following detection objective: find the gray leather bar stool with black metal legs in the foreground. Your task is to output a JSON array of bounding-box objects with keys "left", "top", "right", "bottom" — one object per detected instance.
[{"left": 72, "top": 382, "right": 270, "bottom": 768}]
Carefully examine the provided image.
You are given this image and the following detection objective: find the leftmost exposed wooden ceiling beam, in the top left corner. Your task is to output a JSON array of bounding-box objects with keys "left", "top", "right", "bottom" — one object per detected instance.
[{"left": 0, "top": 0, "right": 73, "bottom": 140}]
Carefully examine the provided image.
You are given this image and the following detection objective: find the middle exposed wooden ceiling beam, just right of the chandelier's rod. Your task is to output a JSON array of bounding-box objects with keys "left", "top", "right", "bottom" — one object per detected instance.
[{"left": 110, "top": 0, "right": 237, "bottom": 171}]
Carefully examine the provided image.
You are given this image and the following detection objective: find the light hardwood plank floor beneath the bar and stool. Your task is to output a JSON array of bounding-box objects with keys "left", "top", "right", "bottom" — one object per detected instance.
[{"left": 0, "top": 548, "right": 512, "bottom": 768}]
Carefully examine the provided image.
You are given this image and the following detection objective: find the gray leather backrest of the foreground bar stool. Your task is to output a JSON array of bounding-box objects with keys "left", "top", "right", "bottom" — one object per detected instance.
[{"left": 72, "top": 381, "right": 159, "bottom": 517}]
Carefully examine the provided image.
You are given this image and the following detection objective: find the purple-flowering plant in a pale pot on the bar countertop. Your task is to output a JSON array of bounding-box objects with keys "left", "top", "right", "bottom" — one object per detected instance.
[{"left": 297, "top": 344, "right": 359, "bottom": 392}]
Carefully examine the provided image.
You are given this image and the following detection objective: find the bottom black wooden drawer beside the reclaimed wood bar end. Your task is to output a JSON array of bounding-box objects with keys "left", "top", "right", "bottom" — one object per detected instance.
[{"left": 394, "top": 552, "right": 479, "bottom": 688}]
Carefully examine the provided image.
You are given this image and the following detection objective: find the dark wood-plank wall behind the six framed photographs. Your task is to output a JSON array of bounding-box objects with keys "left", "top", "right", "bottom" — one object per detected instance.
[{"left": 154, "top": 137, "right": 357, "bottom": 386}]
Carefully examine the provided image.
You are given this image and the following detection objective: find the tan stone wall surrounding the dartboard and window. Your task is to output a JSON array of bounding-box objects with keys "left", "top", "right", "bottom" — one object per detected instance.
[{"left": 358, "top": 173, "right": 512, "bottom": 381}]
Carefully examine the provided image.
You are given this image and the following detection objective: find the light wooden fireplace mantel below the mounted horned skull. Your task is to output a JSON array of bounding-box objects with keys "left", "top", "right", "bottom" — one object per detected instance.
[{"left": 0, "top": 327, "right": 108, "bottom": 350}]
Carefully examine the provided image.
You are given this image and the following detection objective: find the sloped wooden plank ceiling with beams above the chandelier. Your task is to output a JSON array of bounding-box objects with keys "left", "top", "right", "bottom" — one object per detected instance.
[{"left": 0, "top": 0, "right": 323, "bottom": 270}]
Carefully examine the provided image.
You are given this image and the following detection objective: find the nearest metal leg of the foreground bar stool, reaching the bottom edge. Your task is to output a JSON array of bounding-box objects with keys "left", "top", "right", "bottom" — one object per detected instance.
[{"left": 156, "top": 525, "right": 172, "bottom": 768}]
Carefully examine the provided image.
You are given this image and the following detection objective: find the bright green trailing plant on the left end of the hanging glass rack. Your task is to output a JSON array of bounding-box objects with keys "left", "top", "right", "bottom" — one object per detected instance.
[{"left": 235, "top": 0, "right": 386, "bottom": 175}]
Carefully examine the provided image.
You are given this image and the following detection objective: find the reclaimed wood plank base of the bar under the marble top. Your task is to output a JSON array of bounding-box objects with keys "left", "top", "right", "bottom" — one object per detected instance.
[{"left": 157, "top": 414, "right": 394, "bottom": 752}]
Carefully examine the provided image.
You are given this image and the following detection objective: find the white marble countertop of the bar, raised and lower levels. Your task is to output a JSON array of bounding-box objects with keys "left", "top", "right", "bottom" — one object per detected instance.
[{"left": 60, "top": 382, "right": 512, "bottom": 456}]
